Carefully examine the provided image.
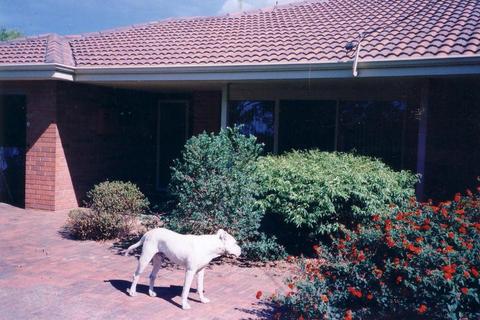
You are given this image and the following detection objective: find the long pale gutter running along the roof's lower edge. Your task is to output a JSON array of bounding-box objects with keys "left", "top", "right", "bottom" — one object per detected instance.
[{"left": 0, "top": 55, "right": 480, "bottom": 82}]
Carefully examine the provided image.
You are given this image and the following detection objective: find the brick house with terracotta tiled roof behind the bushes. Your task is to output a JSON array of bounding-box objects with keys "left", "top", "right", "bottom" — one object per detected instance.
[{"left": 0, "top": 0, "right": 480, "bottom": 210}]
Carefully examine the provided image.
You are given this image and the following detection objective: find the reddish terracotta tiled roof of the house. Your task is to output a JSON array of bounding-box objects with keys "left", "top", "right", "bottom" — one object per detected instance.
[{"left": 0, "top": 0, "right": 480, "bottom": 67}]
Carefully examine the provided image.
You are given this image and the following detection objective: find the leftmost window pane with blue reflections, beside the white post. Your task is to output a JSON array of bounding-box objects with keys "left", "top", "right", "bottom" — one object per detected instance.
[{"left": 228, "top": 100, "right": 275, "bottom": 152}]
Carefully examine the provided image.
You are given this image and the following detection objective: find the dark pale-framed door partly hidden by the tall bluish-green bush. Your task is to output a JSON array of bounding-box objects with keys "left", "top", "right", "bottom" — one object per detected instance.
[{"left": 157, "top": 100, "right": 188, "bottom": 190}]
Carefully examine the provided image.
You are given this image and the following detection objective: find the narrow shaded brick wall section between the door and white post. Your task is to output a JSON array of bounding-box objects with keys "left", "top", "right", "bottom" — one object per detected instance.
[{"left": 190, "top": 91, "right": 222, "bottom": 135}]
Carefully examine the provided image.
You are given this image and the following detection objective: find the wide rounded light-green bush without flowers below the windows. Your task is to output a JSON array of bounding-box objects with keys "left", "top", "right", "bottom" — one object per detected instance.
[{"left": 258, "top": 150, "right": 418, "bottom": 251}]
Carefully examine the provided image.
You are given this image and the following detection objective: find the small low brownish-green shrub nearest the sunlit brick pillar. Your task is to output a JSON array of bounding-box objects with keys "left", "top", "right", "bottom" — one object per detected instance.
[{"left": 66, "top": 181, "right": 149, "bottom": 240}]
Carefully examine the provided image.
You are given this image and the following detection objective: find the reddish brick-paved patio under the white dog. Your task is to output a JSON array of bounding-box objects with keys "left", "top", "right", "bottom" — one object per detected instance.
[{"left": 0, "top": 203, "right": 285, "bottom": 319}]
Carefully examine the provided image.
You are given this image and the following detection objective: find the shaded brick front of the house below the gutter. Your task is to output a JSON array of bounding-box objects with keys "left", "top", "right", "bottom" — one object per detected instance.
[{"left": 0, "top": 77, "right": 480, "bottom": 210}]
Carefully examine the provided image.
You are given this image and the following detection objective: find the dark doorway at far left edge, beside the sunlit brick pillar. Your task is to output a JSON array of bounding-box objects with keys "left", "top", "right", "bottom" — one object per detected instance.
[{"left": 0, "top": 95, "right": 26, "bottom": 207}]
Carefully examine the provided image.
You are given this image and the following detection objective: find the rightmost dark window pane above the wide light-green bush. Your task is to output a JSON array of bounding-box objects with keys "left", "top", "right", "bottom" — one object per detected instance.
[{"left": 338, "top": 101, "right": 407, "bottom": 169}]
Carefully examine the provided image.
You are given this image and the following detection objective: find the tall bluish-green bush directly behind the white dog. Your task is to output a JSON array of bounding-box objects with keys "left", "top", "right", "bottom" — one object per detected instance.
[{"left": 168, "top": 127, "right": 282, "bottom": 260}]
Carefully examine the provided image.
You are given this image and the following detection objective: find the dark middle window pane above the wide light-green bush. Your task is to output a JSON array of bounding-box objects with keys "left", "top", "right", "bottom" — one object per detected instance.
[{"left": 278, "top": 100, "right": 337, "bottom": 152}]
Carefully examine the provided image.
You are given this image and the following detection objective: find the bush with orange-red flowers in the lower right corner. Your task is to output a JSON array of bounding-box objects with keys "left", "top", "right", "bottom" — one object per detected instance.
[{"left": 273, "top": 187, "right": 480, "bottom": 319}]
